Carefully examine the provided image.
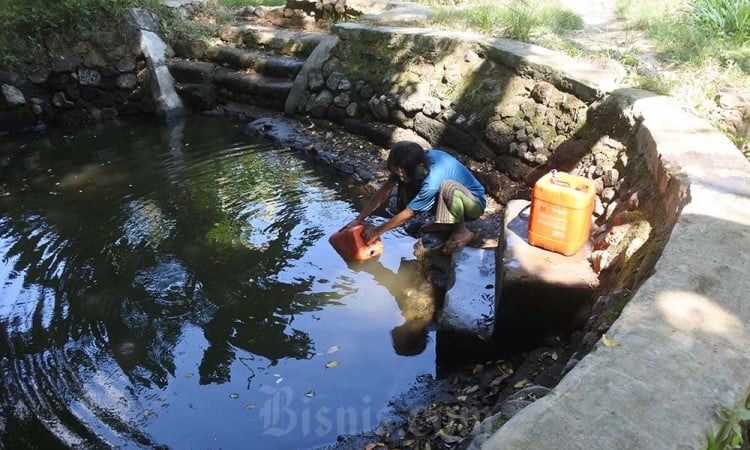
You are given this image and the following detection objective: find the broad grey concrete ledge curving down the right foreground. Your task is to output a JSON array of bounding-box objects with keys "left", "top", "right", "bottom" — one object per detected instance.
[{"left": 482, "top": 90, "right": 750, "bottom": 449}]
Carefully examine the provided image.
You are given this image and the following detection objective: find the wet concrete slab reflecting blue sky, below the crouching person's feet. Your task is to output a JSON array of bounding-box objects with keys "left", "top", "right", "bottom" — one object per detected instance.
[{"left": 438, "top": 247, "right": 495, "bottom": 341}]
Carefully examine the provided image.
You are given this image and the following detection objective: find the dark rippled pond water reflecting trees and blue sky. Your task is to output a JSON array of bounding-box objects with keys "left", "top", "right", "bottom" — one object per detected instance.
[{"left": 0, "top": 118, "right": 435, "bottom": 448}]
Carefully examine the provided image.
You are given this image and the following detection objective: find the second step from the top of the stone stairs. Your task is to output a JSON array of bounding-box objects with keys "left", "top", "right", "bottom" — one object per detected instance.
[{"left": 205, "top": 45, "right": 305, "bottom": 79}]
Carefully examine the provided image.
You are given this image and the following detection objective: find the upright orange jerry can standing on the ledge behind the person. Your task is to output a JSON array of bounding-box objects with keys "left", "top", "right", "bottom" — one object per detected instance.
[{"left": 529, "top": 170, "right": 596, "bottom": 256}]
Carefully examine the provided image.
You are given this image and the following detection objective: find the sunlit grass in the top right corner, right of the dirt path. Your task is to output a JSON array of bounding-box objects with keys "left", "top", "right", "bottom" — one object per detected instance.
[{"left": 618, "top": 0, "right": 750, "bottom": 153}]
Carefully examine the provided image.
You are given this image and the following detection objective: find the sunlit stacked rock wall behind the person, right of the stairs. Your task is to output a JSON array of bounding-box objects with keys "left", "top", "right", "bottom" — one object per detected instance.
[{"left": 295, "top": 24, "right": 588, "bottom": 200}]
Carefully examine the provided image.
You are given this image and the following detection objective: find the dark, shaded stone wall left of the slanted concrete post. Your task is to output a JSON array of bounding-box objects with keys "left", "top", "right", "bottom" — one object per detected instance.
[{"left": 0, "top": 21, "right": 155, "bottom": 134}]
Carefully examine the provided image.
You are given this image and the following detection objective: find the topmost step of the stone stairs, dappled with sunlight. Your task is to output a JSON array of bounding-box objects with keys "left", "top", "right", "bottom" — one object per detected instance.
[{"left": 219, "top": 25, "right": 328, "bottom": 58}]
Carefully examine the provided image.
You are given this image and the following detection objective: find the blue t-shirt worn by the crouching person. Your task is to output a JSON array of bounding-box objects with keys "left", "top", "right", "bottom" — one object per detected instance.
[{"left": 396, "top": 149, "right": 487, "bottom": 212}]
